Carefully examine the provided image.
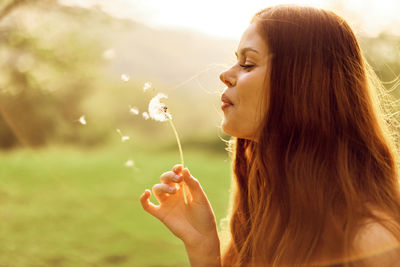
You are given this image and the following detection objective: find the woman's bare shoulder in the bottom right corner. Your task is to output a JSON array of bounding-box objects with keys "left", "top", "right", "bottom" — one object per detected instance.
[{"left": 353, "top": 220, "right": 400, "bottom": 267}]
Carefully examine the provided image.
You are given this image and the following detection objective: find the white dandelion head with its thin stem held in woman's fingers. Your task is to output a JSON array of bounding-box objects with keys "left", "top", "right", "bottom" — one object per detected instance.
[{"left": 149, "top": 93, "right": 187, "bottom": 204}]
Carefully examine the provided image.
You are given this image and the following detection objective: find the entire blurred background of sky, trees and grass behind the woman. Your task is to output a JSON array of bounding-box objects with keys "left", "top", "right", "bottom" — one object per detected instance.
[{"left": 0, "top": 0, "right": 400, "bottom": 267}]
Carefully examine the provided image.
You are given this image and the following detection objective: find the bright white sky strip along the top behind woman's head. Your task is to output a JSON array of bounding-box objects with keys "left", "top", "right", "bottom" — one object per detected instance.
[{"left": 59, "top": 0, "right": 400, "bottom": 39}]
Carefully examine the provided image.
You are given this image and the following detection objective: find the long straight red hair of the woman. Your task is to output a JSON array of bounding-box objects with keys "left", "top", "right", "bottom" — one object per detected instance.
[{"left": 222, "top": 5, "right": 400, "bottom": 266}]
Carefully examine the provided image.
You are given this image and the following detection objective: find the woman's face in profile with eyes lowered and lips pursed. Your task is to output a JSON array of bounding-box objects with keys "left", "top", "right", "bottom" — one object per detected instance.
[{"left": 220, "top": 23, "right": 268, "bottom": 140}]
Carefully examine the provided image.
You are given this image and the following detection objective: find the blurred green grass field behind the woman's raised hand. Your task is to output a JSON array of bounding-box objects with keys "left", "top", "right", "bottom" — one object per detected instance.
[{"left": 0, "top": 145, "right": 231, "bottom": 267}]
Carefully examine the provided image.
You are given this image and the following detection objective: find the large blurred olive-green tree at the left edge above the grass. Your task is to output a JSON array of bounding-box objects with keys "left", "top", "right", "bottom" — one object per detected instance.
[{"left": 0, "top": 0, "right": 108, "bottom": 147}]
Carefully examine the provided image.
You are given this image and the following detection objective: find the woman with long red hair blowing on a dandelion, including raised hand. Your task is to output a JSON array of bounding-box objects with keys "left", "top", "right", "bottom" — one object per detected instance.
[{"left": 141, "top": 6, "right": 400, "bottom": 267}]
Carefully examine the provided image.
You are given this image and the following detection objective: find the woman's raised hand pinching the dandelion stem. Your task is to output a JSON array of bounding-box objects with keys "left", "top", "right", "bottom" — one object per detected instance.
[{"left": 140, "top": 165, "right": 219, "bottom": 250}]
